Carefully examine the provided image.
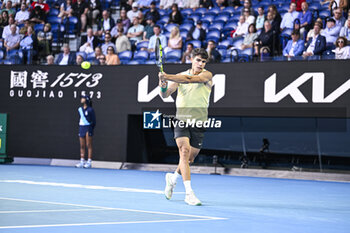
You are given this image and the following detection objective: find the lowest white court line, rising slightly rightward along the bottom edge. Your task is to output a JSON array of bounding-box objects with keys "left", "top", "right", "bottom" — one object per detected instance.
[{"left": 0, "top": 219, "right": 224, "bottom": 229}]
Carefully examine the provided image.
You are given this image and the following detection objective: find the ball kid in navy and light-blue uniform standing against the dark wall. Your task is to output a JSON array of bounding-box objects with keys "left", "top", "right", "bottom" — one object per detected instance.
[{"left": 75, "top": 95, "right": 96, "bottom": 168}]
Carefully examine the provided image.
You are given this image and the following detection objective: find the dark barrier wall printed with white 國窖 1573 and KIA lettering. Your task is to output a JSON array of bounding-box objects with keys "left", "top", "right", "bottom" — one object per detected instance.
[{"left": 0, "top": 61, "right": 350, "bottom": 161}]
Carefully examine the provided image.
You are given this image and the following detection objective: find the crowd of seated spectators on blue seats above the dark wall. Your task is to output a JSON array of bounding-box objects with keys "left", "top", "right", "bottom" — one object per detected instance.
[{"left": 0, "top": 0, "right": 350, "bottom": 65}]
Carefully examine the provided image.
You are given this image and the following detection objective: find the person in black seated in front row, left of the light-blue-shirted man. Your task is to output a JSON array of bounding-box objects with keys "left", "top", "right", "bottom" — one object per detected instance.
[{"left": 254, "top": 21, "right": 275, "bottom": 56}]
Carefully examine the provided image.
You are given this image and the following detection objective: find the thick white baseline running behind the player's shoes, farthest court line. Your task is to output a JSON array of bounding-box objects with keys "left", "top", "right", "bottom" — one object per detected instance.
[{"left": 0, "top": 180, "right": 184, "bottom": 195}]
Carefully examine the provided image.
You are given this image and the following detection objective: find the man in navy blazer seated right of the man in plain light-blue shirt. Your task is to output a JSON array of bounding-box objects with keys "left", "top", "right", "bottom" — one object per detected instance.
[{"left": 303, "top": 23, "right": 326, "bottom": 58}]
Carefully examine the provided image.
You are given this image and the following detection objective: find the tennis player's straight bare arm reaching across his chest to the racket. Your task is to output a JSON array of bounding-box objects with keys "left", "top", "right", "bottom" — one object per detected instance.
[{"left": 159, "top": 71, "right": 213, "bottom": 83}]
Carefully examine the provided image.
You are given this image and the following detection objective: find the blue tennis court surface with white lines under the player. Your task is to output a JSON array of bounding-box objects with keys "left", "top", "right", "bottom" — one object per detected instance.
[{"left": 0, "top": 165, "right": 350, "bottom": 233}]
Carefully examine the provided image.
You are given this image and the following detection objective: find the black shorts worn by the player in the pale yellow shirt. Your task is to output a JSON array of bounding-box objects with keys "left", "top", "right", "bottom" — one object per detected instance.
[{"left": 174, "top": 125, "right": 205, "bottom": 149}]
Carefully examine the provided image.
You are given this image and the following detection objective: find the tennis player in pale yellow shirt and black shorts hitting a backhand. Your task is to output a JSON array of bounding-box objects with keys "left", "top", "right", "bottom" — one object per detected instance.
[{"left": 158, "top": 48, "right": 213, "bottom": 205}]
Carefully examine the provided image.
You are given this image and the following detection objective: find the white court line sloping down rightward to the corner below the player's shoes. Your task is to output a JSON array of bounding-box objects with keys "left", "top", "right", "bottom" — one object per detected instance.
[{"left": 0, "top": 197, "right": 227, "bottom": 220}]
